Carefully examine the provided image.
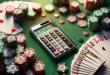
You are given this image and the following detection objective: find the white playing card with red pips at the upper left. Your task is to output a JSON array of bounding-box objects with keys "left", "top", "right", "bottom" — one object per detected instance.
[{"left": 0, "top": 1, "right": 23, "bottom": 34}]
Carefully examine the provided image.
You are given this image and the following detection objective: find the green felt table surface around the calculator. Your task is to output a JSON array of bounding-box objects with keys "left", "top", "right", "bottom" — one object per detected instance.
[{"left": 0, "top": 0, "right": 110, "bottom": 75}]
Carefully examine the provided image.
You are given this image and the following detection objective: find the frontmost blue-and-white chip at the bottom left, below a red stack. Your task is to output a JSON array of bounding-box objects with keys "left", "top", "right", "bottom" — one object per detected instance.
[{"left": 6, "top": 64, "right": 20, "bottom": 75}]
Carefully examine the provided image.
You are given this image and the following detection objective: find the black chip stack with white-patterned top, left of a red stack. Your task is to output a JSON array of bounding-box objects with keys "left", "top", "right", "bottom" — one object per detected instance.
[{"left": 6, "top": 35, "right": 18, "bottom": 48}]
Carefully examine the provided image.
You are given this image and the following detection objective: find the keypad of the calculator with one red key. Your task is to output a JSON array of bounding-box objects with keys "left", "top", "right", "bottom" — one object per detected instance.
[{"left": 40, "top": 28, "right": 73, "bottom": 56}]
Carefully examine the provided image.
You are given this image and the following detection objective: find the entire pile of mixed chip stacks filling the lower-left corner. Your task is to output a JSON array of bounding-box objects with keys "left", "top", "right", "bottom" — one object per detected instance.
[{"left": 0, "top": 32, "right": 45, "bottom": 75}]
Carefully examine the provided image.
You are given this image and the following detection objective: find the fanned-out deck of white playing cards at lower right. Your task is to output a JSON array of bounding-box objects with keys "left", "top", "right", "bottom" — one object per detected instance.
[{"left": 71, "top": 31, "right": 110, "bottom": 75}]
